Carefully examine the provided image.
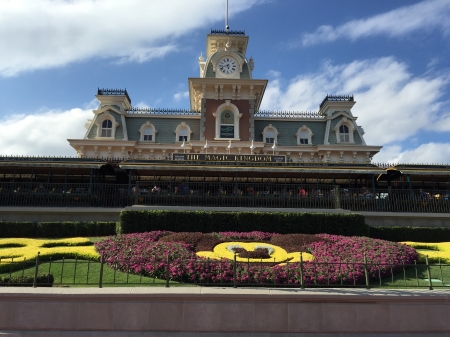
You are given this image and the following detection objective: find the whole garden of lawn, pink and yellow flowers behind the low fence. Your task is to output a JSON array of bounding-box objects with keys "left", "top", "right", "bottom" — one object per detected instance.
[{"left": 0, "top": 212, "right": 450, "bottom": 287}]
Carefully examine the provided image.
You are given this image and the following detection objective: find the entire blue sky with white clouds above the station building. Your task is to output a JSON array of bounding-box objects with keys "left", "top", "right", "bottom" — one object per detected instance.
[{"left": 0, "top": 0, "right": 450, "bottom": 163}]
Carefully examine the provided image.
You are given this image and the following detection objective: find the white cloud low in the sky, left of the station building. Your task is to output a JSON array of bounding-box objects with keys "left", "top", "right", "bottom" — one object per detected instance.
[{"left": 0, "top": 108, "right": 93, "bottom": 156}]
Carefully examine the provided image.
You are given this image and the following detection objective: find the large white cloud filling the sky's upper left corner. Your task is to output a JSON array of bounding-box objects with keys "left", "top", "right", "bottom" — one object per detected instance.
[{"left": 0, "top": 0, "right": 256, "bottom": 76}]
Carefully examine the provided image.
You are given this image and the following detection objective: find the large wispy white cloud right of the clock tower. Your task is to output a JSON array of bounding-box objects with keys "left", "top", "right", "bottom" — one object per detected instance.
[{"left": 261, "top": 57, "right": 450, "bottom": 145}]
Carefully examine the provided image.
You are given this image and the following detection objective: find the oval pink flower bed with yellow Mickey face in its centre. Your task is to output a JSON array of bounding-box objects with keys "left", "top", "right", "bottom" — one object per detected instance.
[{"left": 96, "top": 231, "right": 417, "bottom": 285}]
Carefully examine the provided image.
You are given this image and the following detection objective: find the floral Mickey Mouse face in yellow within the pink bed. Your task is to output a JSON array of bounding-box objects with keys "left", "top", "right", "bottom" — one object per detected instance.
[{"left": 197, "top": 241, "right": 314, "bottom": 263}]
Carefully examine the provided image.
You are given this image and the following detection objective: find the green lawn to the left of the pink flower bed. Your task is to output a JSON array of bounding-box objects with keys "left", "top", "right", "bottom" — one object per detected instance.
[{"left": 0, "top": 259, "right": 190, "bottom": 287}]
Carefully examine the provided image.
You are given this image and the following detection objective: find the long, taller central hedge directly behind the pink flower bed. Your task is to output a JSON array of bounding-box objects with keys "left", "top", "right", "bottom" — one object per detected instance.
[{"left": 117, "top": 211, "right": 369, "bottom": 236}]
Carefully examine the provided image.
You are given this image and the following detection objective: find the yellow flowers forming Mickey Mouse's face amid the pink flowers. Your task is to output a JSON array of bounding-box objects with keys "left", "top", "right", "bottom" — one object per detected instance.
[{"left": 197, "top": 241, "right": 314, "bottom": 263}]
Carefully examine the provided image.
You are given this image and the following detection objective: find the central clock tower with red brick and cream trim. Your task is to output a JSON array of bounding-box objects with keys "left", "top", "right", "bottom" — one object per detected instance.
[{"left": 188, "top": 29, "right": 268, "bottom": 148}]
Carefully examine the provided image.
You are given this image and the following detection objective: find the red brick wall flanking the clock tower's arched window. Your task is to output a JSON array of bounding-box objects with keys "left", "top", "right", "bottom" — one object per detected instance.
[{"left": 205, "top": 99, "right": 250, "bottom": 141}]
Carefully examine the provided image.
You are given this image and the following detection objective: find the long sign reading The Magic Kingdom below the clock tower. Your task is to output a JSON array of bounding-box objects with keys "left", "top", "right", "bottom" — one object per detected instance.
[{"left": 172, "top": 153, "right": 286, "bottom": 163}]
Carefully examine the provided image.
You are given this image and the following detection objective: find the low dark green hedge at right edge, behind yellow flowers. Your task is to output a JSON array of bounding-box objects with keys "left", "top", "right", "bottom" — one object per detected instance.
[{"left": 370, "top": 227, "right": 450, "bottom": 242}]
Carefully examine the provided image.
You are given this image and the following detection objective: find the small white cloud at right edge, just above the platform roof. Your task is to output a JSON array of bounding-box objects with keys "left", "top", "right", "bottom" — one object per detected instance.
[{"left": 373, "top": 142, "right": 450, "bottom": 164}]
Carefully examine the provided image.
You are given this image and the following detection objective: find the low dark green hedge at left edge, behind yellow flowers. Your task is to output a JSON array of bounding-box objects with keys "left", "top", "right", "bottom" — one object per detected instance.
[{"left": 0, "top": 221, "right": 117, "bottom": 238}]
